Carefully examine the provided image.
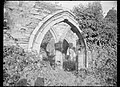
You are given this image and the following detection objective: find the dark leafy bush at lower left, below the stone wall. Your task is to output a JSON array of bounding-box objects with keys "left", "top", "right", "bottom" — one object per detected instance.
[{"left": 3, "top": 45, "right": 38, "bottom": 86}]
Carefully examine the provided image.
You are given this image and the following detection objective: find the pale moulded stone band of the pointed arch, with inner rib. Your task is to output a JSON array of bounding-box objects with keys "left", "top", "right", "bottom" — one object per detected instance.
[{"left": 28, "top": 10, "right": 87, "bottom": 66}]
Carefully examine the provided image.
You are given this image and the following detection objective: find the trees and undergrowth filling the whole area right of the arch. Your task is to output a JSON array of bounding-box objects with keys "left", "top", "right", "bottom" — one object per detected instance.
[{"left": 73, "top": 2, "right": 117, "bottom": 85}]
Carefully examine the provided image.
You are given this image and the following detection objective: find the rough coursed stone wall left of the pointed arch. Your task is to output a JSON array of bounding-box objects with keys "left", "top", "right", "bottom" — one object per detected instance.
[{"left": 4, "top": 1, "right": 60, "bottom": 50}]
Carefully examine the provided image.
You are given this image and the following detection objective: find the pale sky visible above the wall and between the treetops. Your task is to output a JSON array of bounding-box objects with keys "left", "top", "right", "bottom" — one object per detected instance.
[{"left": 49, "top": 1, "right": 117, "bottom": 16}]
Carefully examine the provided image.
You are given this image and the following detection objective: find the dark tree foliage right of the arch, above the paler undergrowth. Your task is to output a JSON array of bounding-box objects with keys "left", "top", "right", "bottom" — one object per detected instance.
[{"left": 73, "top": 2, "right": 117, "bottom": 51}]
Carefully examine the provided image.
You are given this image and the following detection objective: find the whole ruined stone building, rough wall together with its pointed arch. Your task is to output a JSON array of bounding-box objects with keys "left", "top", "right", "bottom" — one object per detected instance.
[{"left": 4, "top": 1, "right": 92, "bottom": 68}]
